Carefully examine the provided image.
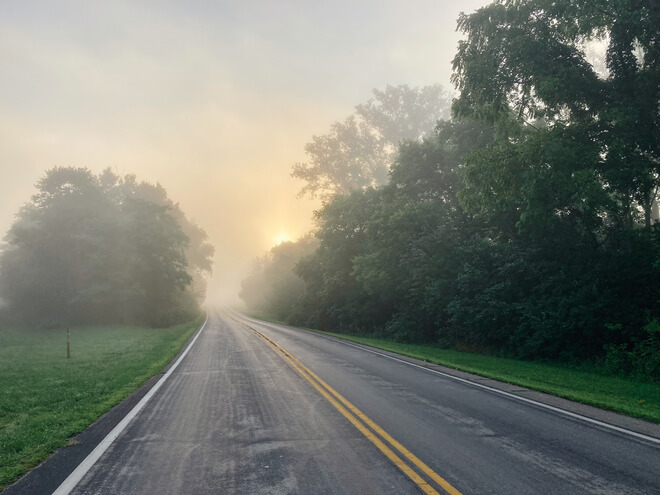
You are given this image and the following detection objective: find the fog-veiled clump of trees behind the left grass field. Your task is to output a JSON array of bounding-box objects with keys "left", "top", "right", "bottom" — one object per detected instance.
[{"left": 0, "top": 167, "right": 213, "bottom": 326}]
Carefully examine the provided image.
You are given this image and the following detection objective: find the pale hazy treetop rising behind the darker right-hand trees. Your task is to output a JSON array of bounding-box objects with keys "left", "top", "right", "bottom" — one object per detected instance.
[{"left": 291, "top": 85, "right": 450, "bottom": 199}]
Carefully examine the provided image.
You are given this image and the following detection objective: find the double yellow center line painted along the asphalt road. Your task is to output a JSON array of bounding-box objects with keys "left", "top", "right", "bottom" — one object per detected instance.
[{"left": 235, "top": 320, "right": 461, "bottom": 495}]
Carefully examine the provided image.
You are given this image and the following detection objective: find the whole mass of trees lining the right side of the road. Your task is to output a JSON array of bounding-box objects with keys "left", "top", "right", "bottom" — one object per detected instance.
[{"left": 242, "top": 0, "right": 660, "bottom": 378}]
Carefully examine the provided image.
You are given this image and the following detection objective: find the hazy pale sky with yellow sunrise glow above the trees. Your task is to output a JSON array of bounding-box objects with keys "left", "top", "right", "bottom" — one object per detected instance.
[{"left": 0, "top": 0, "right": 488, "bottom": 300}]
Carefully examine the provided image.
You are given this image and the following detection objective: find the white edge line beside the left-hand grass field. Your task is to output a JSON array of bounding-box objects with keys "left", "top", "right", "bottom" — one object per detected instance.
[{"left": 53, "top": 313, "right": 209, "bottom": 495}]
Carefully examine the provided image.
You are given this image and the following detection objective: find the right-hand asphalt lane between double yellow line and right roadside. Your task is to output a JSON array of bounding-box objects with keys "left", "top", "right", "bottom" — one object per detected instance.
[{"left": 231, "top": 317, "right": 660, "bottom": 494}]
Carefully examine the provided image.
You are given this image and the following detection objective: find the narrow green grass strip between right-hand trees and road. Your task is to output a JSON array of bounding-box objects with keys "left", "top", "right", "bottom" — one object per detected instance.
[{"left": 252, "top": 314, "right": 660, "bottom": 423}]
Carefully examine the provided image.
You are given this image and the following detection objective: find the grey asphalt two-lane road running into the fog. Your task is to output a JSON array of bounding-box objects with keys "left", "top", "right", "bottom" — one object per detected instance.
[{"left": 15, "top": 311, "right": 660, "bottom": 494}]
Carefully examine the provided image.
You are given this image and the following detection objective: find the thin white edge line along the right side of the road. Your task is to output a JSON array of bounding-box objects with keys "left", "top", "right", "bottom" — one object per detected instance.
[{"left": 241, "top": 315, "right": 660, "bottom": 445}]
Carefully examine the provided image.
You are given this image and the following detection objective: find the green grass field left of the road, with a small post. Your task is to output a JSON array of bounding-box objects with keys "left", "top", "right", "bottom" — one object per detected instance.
[{"left": 0, "top": 319, "right": 203, "bottom": 490}]
